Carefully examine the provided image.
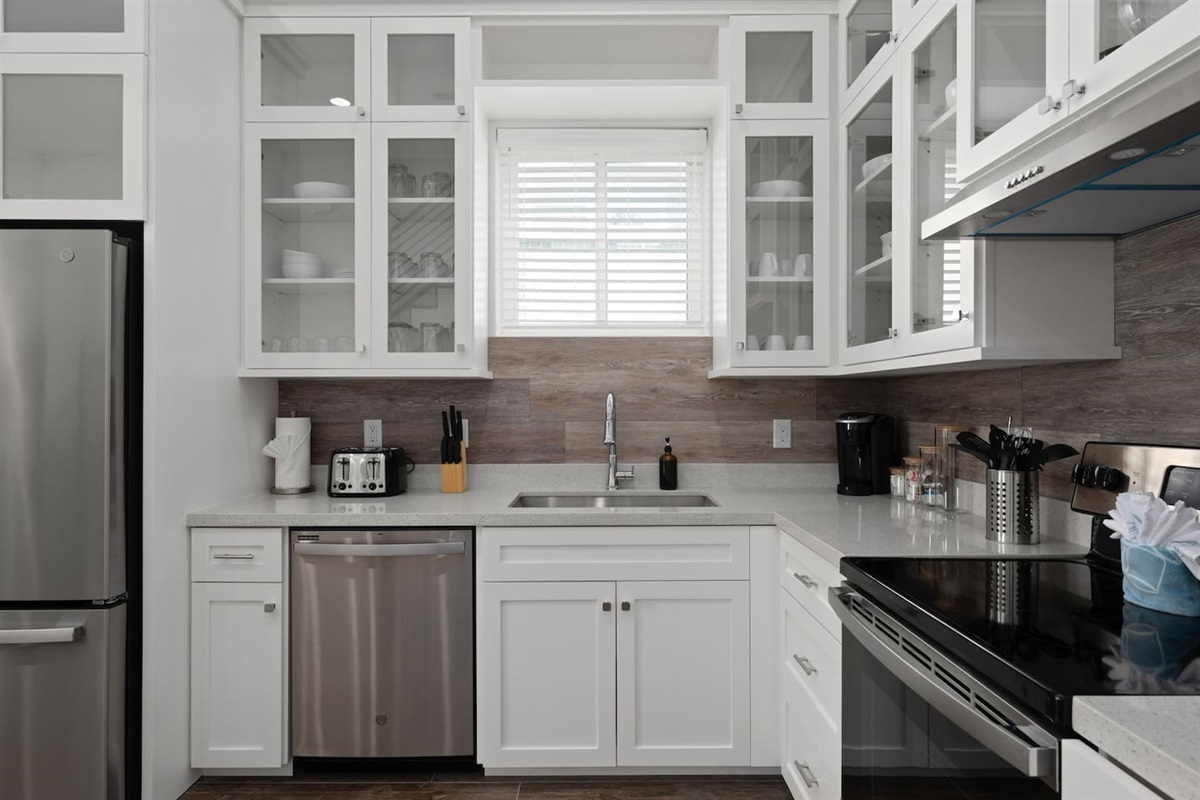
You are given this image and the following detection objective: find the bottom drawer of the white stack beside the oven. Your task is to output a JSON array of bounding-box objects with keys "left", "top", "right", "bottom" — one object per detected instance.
[{"left": 782, "top": 680, "right": 841, "bottom": 800}]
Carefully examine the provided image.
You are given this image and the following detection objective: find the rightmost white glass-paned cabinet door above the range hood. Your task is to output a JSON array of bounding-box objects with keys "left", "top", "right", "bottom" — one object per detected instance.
[{"left": 1058, "top": 0, "right": 1200, "bottom": 113}]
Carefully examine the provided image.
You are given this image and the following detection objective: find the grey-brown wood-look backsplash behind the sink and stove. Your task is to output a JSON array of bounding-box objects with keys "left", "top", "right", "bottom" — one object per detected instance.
[{"left": 280, "top": 212, "right": 1200, "bottom": 499}]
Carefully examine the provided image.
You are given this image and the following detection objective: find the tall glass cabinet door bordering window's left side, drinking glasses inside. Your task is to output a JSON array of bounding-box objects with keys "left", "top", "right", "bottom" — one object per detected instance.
[{"left": 371, "top": 122, "right": 474, "bottom": 375}]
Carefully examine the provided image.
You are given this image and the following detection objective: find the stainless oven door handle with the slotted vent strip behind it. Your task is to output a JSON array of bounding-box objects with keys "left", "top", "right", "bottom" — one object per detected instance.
[{"left": 829, "top": 587, "right": 1058, "bottom": 787}]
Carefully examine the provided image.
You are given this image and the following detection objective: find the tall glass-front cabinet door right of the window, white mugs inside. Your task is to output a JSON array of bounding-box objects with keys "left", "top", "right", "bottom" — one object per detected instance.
[{"left": 730, "top": 121, "right": 832, "bottom": 368}]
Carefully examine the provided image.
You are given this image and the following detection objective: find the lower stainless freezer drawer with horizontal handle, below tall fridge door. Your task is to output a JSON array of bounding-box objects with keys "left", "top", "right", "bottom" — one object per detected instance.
[{"left": 0, "top": 604, "right": 126, "bottom": 800}]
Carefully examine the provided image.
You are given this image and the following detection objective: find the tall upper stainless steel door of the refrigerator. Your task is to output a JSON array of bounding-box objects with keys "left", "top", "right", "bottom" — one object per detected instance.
[{"left": 0, "top": 229, "right": 126, "bottom": 602}]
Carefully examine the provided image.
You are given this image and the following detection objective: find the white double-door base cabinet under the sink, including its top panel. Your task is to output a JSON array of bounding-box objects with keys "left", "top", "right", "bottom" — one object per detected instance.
[{"left": 478, "top": 528, "right": 750, "bottom": 770}]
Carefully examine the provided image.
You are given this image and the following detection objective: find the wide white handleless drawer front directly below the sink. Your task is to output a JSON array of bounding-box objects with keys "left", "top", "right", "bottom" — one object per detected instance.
[{"left": 476, "top": 525, "right": 750, "bottom": 581}]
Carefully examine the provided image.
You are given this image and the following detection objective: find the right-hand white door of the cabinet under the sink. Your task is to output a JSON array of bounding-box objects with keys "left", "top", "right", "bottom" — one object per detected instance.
[{"left": 617, "top": 581, "right": 750, "bottom": 766}]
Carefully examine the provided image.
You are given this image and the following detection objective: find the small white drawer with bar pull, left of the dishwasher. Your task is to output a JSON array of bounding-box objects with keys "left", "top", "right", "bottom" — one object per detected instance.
[{"left": 192, "top": 528, "right": 283, "bottom": 583}]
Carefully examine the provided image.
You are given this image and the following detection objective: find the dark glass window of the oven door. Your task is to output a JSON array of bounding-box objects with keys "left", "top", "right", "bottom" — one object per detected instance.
[{"left": 841, "top": 631, "right": 1058, "bottom": 800}]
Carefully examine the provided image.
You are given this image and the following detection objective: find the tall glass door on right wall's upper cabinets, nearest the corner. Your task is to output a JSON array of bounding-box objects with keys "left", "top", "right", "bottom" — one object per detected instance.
[{"left": 845, "top": 80, "right": 895, "bottom": 354}]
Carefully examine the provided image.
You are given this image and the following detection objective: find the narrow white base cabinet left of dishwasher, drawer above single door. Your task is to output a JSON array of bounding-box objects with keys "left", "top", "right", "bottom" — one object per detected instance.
[{"left": 191, "top": 529, "right": 288, "bottom": 769}]
